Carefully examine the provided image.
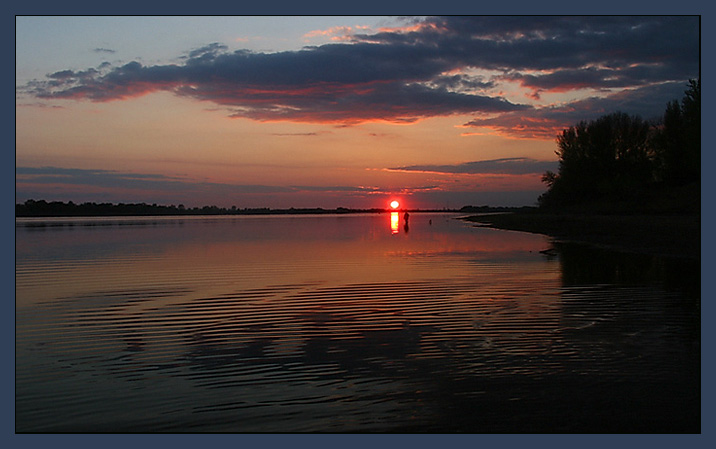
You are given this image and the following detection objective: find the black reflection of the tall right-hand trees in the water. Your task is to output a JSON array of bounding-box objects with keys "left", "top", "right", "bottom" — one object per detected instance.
[{"left": 556, "top": 240, "right": 701, "bottom": 432}]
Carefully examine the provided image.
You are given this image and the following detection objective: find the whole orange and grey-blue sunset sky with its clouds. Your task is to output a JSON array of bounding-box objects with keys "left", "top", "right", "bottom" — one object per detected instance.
[{"left": 15, "top": 16, "right": 700, "bottom": 208}]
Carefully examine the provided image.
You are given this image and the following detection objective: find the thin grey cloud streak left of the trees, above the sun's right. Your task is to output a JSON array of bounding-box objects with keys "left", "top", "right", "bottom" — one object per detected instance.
[{"left": 388, "top": 158, "right": 557, "bottom": 175}]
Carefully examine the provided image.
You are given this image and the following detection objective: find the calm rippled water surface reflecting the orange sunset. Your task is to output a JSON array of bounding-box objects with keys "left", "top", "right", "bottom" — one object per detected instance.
[{"left": 15, "top": 213, "right": 701, "bottom": 433}]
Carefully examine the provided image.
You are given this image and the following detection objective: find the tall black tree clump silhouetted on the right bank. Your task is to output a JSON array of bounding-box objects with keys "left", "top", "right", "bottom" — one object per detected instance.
[{"left": 539, "top": 79, "right": 701, "bottom": 213}]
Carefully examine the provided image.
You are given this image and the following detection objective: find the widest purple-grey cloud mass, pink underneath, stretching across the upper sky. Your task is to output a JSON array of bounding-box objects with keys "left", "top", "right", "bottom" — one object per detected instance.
[{"left": 24, "top": 16, "right": 700, "bottom": 131}]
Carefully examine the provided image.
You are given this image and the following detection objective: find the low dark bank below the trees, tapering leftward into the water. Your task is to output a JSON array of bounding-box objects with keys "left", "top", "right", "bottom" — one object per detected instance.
[{"left": 465, "top": 210, "right": 701, "bottom": 259}]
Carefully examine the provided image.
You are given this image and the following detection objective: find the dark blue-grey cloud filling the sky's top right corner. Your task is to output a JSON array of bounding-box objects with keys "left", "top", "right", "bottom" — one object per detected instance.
[{"left": 355, "top": 16, "right": 700, "bottom": 78}]
